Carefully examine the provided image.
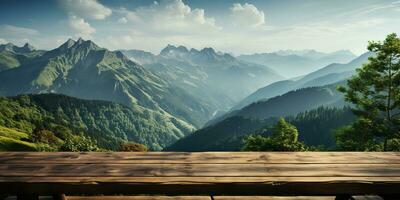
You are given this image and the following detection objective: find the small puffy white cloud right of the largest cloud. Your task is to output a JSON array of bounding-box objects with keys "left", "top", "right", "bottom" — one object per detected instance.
[{"left": 230, "top": 3, "right": 265, "bottom": 27}]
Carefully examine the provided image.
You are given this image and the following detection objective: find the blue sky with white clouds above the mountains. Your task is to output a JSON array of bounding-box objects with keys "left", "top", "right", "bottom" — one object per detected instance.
[{"left": 0, "top": 0, "right": 400, "bottom": 55}]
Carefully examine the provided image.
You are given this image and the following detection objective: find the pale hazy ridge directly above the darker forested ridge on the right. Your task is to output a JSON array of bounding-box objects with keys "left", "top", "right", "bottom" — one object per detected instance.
[{"left": 233, "top": 52, "right": 373, "bottom": 109}]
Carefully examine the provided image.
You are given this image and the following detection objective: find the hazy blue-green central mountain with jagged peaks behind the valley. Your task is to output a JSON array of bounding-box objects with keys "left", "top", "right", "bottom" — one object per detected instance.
[{"left": 122, "top": 45, "right": 282, "bottom": 115}]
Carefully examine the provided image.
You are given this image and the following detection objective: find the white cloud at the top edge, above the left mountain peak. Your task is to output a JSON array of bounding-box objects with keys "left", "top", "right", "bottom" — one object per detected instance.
[{"left": 59, "top": 0, "right": 112, "bottom": 20}]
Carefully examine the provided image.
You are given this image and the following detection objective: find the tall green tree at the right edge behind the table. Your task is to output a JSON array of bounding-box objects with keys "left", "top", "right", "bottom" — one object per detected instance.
[{"left": 337, "top": 33, "right": 400, "bottom": 151}]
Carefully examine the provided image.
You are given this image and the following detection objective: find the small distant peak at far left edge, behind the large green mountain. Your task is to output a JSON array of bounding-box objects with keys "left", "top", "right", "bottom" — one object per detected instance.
[{"left": 0, "top": 43, "right": 44, "bottom": 72}]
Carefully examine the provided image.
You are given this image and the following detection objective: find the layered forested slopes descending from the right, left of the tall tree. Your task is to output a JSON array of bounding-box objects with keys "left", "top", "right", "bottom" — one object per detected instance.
[{"left": 167, "top": 52, "right": 373, "bottom": 151}]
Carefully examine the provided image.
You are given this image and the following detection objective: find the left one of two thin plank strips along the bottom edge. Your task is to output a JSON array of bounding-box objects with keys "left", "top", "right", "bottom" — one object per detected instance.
[{"left": 67, "top": 196, "right": 211, "bottom": 200}]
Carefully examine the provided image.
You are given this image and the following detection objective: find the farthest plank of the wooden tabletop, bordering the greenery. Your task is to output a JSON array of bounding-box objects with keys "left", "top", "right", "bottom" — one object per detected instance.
[{"left": 0, "top": 152, "right": 400, "bottom": 164}]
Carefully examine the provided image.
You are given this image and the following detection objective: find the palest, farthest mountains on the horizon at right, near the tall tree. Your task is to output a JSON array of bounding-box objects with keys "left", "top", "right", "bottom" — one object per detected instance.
[{"left": 238, "top": 50, "right": 356, "bottom": 77}]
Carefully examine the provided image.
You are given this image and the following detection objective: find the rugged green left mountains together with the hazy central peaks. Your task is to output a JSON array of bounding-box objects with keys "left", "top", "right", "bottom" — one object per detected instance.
[{"left": 0, "top": 39, "right": 282, "bottom": 149}]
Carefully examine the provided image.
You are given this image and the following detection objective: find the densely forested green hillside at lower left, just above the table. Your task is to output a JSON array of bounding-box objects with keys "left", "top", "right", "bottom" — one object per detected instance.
[{"left": 0, "top": 94, "right": 190, "bottom": 151}]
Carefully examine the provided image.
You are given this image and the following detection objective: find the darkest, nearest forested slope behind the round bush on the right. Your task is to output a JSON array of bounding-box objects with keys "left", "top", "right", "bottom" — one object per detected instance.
[{"left": 166, "top": 107, "right": 354, "bottom": 151}]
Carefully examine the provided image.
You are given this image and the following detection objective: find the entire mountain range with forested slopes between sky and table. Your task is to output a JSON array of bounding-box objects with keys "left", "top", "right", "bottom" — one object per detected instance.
[{"left": 0, "top": 38, "right": 372, "bottom": 151}]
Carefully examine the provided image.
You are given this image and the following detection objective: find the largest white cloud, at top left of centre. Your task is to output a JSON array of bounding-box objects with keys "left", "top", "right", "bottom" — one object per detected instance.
[{"left": 120, "top": 0, "right": 220, "bottom": 34}]
